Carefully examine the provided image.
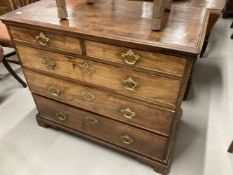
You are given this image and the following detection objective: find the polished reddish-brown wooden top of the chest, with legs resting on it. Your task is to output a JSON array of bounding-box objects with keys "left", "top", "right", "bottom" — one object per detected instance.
[{"left": 1, "top": 0, "right": 208, "bottom": 56}]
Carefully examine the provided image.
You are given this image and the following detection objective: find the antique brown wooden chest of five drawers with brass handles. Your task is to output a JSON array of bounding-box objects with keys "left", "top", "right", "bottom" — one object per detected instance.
[{"left": 1, "top": 0, "right": 218, "bottom": 174}]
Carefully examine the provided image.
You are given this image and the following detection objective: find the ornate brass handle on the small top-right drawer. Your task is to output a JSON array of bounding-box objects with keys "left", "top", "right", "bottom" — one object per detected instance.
[{"left": 121, "top": 49, "right": 141, "bottom": 66}]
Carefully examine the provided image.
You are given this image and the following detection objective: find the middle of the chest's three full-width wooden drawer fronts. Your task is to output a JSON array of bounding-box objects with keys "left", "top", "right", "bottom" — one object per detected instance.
[{"left": 24, "top": 70, "right": 174, "bottom": 136}]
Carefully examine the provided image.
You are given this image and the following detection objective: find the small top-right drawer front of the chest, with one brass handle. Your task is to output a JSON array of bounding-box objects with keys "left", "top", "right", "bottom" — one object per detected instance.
[{"left": 85, "top": 41, "right": 186, "bottom": 77}]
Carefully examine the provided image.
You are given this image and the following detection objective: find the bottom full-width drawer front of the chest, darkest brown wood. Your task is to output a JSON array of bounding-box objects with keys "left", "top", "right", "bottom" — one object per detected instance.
[{"left": 34, "top": 95, "right": 167, "bottom": 160}]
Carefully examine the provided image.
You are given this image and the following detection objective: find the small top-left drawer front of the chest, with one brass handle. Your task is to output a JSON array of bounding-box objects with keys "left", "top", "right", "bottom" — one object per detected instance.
[{"left": 10, "top": 26, "right": 82, "bottom": 54}]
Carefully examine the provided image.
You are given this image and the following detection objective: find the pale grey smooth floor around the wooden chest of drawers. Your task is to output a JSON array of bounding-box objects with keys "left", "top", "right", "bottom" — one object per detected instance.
[{"left": 0, "top": 19, "right": 233, "bottom": 175}]
